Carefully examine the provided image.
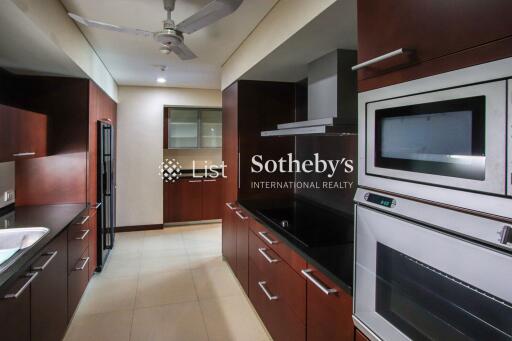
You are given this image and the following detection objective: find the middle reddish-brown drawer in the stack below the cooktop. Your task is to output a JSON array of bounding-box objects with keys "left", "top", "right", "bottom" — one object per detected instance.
[{"left": 249, "top": 232, "right": 306, "bottom": 324}]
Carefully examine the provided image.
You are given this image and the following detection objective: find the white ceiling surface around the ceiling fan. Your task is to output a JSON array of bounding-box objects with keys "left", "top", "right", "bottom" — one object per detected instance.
[{"left": 61, "top": 0, "right": 277, "bottom": 89}]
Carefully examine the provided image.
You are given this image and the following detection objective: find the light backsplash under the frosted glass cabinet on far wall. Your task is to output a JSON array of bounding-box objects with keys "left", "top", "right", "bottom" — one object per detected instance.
[{"left": 164, "top": 148, "right": 222, "bottom": 169}]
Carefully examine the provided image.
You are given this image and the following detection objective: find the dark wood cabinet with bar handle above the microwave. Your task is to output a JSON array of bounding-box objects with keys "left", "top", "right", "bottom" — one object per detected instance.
[{"left": 357, "top": 0, "right": 512, "bottom": 91}]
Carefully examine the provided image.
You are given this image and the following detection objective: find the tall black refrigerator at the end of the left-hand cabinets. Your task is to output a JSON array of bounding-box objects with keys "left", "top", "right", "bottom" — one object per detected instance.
[{"left": 98, "top": 121, "right": 116, "bottom": 271}]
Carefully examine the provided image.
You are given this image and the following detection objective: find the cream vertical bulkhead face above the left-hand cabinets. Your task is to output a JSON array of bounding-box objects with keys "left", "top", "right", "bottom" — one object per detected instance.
[{"left": 11, "top": 0, "right": 118, "bottom": 101}]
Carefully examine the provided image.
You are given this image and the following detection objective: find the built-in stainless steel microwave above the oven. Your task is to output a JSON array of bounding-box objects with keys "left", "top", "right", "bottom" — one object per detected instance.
[{"left": 358, "top": 58, "right": 512, "bottom": 218}]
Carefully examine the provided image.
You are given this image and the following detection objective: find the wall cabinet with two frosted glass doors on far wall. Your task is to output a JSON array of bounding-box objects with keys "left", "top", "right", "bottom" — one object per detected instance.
[{"left": 164, "top": 108, "right": 222, "bottom": 149}]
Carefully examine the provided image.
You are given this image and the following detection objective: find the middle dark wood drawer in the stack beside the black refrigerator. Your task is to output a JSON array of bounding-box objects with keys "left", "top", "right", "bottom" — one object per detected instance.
[{"left": 68, "top": 211, "right": 91, "bottom": 272}]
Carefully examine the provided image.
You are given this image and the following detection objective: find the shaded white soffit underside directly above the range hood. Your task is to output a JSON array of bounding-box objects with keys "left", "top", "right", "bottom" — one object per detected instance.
[{"left": 242, "top": 0, "right": 357, "bottom": 82}]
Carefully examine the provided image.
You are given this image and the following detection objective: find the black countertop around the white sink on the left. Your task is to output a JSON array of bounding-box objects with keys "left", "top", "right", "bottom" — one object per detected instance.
[{"left": 0, "top": 204, "right": 87, "bottom": 287}]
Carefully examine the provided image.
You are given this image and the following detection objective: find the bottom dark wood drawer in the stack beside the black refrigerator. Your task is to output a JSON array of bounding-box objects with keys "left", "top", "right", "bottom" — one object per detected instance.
[{"left": 68, "top": 248, "right": 89, "bottom": 320}]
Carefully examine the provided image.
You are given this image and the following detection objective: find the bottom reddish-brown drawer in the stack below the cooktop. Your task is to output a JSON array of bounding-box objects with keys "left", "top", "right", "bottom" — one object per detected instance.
[{"left": 249, "top": 260, "right": 306, "bottom": 341}]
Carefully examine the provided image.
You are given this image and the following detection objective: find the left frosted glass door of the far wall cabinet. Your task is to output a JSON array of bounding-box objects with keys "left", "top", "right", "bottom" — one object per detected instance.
[{"left": 167, "top": 109, "right": 199, "bottom": 148}]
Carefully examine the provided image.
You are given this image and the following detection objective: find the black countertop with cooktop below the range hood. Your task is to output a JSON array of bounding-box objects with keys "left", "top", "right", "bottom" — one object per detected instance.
[{"left": 238, "top": 200, "right": 354, "bottom": 295}]
